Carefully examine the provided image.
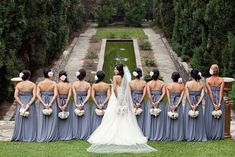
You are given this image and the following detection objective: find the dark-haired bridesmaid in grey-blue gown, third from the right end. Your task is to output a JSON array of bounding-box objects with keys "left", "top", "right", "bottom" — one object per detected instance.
[{"left": 166, "top": 72, "right": 184, "bottom": 141}]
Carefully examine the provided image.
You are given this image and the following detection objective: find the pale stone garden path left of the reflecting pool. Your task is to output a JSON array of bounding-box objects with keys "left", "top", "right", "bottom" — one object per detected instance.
[{"left": 64, "top": 27, "right": 96, "bottom": 82}]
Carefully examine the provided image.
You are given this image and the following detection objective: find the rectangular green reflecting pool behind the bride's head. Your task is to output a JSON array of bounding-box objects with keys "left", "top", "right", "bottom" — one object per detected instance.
[{"left": 103, "top": 40, "right": 136, "bottom": 83}]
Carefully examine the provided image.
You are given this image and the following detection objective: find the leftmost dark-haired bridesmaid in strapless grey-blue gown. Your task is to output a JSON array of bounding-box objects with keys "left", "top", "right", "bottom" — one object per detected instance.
[{"left": 12, "top": 70, "right": 37, "bottom": 142}]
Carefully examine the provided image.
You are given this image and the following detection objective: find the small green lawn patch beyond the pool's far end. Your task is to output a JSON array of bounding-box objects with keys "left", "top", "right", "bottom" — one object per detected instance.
[{"left": 95, "top": 27, "right": 147, "bottom": 39}]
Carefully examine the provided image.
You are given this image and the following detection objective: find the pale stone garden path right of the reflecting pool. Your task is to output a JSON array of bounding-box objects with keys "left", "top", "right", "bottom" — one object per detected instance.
[{"left": 144, "top": 28, "right": 177, "bottom": 82}]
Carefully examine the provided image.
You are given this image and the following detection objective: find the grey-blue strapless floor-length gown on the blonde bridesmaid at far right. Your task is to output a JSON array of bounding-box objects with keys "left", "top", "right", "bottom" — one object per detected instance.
[{"left": 205, "top": 86, "right": 224, "bottom": 140}]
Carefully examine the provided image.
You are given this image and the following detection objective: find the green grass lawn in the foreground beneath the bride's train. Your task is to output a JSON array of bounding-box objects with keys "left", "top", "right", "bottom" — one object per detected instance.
[{"left": 0, "top": 140, "right": 235, "bottom": 157}]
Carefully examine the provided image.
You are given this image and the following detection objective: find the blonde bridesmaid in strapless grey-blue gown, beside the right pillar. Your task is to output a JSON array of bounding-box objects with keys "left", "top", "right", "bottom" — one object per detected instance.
[{"left": 205, "top": 64, "right": 224, "bottom": 140}]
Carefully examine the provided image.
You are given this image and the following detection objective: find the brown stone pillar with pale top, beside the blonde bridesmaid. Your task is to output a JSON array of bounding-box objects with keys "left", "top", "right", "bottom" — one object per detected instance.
[{"left": 223, "top": 77, "right": 235, "bottom": 139}]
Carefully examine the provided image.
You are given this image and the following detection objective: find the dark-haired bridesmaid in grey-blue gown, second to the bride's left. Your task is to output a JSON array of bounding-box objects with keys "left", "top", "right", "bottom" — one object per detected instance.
[{"left": 72, "top": 69, "right": 91, "bottom": 139}]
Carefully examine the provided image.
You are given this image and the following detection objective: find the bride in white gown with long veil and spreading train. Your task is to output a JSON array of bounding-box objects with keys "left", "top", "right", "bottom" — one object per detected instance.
[{"left": 87, "top": 64, "right": 155, "bottom": 153}]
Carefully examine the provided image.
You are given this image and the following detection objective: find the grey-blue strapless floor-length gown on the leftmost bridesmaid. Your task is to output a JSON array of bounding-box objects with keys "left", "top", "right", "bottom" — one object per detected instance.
[{"left": 12, "top": 92, "right": 37, "bottom": 142}]
